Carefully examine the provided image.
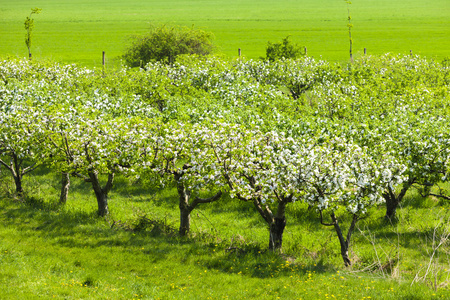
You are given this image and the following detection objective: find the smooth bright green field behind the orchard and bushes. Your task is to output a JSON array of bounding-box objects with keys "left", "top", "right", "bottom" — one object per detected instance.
[{"left": 0, "top": 0, "right": 450, "bottom": 66}]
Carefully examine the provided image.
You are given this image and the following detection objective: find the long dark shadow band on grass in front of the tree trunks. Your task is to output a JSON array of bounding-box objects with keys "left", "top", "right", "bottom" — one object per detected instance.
[{"left": 0, "top": 192, "right": 332, "bottom": 278}]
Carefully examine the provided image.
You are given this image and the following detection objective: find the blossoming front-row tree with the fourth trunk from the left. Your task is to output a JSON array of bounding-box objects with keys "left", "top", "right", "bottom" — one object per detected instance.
[{"left": 143, "top": 124, "right": 223, "bottom": 236}]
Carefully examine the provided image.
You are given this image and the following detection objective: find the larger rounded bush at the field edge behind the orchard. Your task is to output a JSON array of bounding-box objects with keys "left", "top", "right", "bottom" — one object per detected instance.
[{"left": 123, "top": 25, "right": 214, "bottom": 67}]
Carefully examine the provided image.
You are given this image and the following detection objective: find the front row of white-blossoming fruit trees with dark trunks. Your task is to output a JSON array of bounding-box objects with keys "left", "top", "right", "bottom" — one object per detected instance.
[{"left": 0, "top": 107, "right": 450, "bottom": 264}]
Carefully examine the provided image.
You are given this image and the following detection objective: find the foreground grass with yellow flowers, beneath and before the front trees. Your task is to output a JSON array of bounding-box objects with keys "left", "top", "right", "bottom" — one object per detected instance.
[{"left": 0, "top": 169, "right": 450, "bottom": 299}]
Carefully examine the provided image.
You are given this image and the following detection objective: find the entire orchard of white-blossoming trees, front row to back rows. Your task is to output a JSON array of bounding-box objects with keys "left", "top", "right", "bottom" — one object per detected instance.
[{"left": 0, "top": 55, "right": 450, "bottom": 265}]
